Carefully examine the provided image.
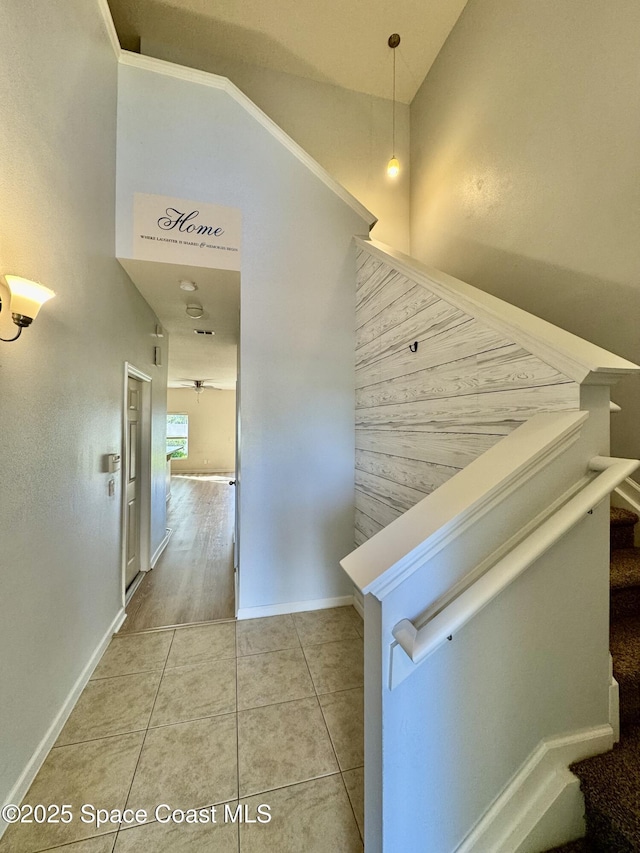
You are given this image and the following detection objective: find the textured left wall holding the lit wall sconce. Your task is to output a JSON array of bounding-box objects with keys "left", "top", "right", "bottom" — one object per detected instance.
[{"left": 0, "top": 0, "right": 166, "bottom": 802}]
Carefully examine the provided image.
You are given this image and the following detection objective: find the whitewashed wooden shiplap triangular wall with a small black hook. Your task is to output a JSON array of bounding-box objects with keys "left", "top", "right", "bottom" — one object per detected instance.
[{"left": 355, "top": 249, "right": 580, "bottom": 545}]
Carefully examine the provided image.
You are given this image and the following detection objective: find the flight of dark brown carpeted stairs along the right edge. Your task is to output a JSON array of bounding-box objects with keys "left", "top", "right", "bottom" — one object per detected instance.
[{"left": 549, "top": 507, "right": 640, "bottom": 853}]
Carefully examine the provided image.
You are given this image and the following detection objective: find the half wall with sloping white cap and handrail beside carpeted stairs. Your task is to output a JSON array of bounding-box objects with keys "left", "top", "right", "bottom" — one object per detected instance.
[{"left": 342, "top": 410, "right": 640, "bottom": 853}]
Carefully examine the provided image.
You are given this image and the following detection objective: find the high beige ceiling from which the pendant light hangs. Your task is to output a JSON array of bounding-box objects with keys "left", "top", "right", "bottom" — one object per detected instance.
[{"left": 108, "top": 0, "right": 467, "bottom": 103}]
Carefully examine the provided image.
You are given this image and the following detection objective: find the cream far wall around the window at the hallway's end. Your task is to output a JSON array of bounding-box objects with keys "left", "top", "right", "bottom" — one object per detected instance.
[{"left": 167, "top": 388, "right": 236, "bottom": 474}]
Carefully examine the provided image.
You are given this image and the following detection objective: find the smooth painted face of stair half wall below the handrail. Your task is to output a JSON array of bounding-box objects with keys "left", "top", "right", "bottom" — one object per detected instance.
[{"left": 374, "top": 504, "right": 609, "bottom": 851}]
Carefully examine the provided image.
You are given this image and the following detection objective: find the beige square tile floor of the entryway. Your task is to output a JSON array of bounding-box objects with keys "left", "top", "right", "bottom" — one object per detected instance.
[{"left": 0, "top": 607, "right": 364, "bottom": 853}]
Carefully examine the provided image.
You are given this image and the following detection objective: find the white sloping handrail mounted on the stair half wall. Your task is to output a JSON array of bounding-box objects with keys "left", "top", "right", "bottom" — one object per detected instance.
[{"left": 392, "top": 456, "right": 640, "bottom": 664}]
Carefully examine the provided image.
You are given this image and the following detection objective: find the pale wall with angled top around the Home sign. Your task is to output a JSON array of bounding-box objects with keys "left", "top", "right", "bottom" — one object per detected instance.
[{"left": 112, "top": 58, "right": 368, "bottom": 609}]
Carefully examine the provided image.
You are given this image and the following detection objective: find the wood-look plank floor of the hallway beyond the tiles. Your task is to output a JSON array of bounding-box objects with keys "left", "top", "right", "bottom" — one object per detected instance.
[{"left": 119, "top": 474, "right": 235, "bottom": 634}]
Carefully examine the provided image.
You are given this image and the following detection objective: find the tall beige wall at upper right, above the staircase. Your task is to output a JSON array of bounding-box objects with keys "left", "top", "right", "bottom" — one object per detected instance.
[{"left": 411, "top": 0, "right": 640, "bottom": 456}]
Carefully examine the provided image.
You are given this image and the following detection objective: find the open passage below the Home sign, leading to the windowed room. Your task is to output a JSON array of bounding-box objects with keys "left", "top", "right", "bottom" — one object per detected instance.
[{"left": 120, "top": 260, "right": 240, "bottom": 634}]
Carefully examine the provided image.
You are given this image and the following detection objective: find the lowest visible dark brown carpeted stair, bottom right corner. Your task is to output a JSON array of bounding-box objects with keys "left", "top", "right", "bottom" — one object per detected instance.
[{"left": 571, "top": 726, "right": 640, "bottom": 853}]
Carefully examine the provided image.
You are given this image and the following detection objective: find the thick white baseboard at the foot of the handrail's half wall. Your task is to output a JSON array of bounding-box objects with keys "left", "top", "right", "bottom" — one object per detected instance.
[{"left": 455, "top": 725, "right": 613, "bottom": 853}]
